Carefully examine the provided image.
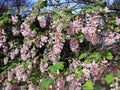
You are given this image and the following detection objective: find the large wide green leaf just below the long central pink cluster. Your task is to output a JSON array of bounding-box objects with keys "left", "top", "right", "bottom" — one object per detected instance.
[{"left": 48, "top": 62, "right": 64, "bottom": 74}]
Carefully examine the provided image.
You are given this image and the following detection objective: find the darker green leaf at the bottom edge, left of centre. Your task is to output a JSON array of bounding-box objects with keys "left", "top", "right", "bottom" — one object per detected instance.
[{"left": 39, "top": 77, "right": 52, "bottom": 90}]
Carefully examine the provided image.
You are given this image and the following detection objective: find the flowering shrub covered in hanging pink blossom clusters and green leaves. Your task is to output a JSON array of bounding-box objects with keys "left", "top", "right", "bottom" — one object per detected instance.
[{"left": 0, "top": 1, "right": 120, "bottom": 90}]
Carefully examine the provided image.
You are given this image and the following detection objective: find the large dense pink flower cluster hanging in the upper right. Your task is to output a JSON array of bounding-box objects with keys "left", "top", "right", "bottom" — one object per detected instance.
[{"left": 82, "top": 12, "right": 99, "bottom": 45}]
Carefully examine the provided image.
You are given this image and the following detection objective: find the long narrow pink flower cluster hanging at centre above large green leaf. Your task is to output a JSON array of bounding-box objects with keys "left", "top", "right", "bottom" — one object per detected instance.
[{"left": 48, "top": 22, "right": 64, "bottom": 64}]
